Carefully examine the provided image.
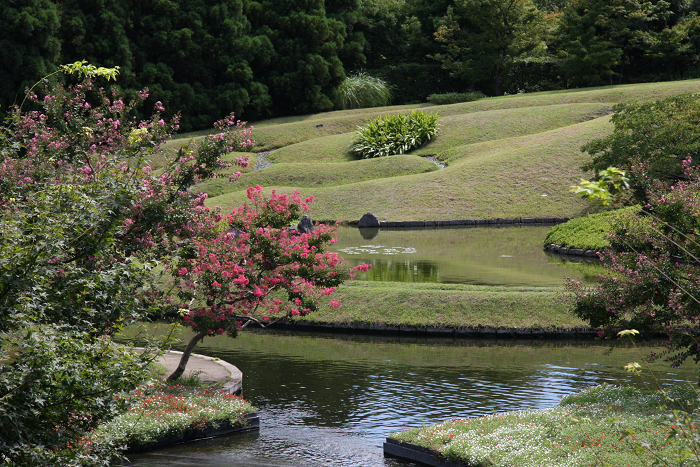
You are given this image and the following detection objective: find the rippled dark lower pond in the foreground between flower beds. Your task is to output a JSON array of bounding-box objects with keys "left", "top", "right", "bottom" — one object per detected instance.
[{"left": 117, "top": 331, "right": 697, "bottom": 467}]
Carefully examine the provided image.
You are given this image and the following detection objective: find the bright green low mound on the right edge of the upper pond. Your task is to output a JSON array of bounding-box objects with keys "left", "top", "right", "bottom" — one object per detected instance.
[{"left": 544, "top": 206, "right": 639, "bottom": 251}]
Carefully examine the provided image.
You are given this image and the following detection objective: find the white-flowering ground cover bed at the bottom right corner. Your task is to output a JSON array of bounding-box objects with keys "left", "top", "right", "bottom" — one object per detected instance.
[{"left": 391, "top": 385, "right": 700, "bottom": 467}]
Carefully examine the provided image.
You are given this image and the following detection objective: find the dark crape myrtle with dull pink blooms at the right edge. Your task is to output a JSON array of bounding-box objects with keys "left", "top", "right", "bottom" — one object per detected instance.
[{"left": 568, "top": 160, "right": 700, "bottom": 374}]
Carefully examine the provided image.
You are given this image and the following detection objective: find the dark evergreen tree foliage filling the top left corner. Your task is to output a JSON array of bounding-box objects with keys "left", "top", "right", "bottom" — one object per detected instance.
[{"left": 0, "top": 0, "right": 61, "bottom": 108}]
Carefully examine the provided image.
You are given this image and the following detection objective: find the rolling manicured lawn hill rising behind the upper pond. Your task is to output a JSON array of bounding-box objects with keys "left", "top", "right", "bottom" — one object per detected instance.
[{"left": 170, "top": 80, "right": 700, "bottom": 221}]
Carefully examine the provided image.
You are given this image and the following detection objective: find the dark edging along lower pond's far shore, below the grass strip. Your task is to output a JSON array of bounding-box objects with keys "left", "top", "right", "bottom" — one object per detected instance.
[{"left": 274, "top": 320, "right": 598, "bottom": 339}]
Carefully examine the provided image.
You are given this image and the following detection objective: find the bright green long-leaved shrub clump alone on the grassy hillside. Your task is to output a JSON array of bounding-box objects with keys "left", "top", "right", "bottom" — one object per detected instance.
[{"left": 350, "top": 110, "right": 438, "bottom": 159}]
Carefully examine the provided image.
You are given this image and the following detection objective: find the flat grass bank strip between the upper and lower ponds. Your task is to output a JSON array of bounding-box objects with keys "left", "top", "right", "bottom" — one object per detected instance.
[{"left": 299, "top": 281, "right": 588, "bottom": 331}]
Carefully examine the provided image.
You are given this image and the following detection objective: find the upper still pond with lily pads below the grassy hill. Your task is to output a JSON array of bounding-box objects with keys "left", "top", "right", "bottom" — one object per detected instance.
[{"left": 331, "top": 226, "right": 604, "bottom": 287}]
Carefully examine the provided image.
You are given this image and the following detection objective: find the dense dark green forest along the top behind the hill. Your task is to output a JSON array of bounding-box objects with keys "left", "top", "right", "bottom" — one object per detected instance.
[{"left": 0, "top": 0, "right": 700, "bottom": 130}]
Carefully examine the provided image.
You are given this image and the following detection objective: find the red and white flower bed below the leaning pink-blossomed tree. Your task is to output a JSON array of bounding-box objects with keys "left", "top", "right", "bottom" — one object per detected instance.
[{"left": 96, "top": 384, "right": 256, "bottom": 449}]
